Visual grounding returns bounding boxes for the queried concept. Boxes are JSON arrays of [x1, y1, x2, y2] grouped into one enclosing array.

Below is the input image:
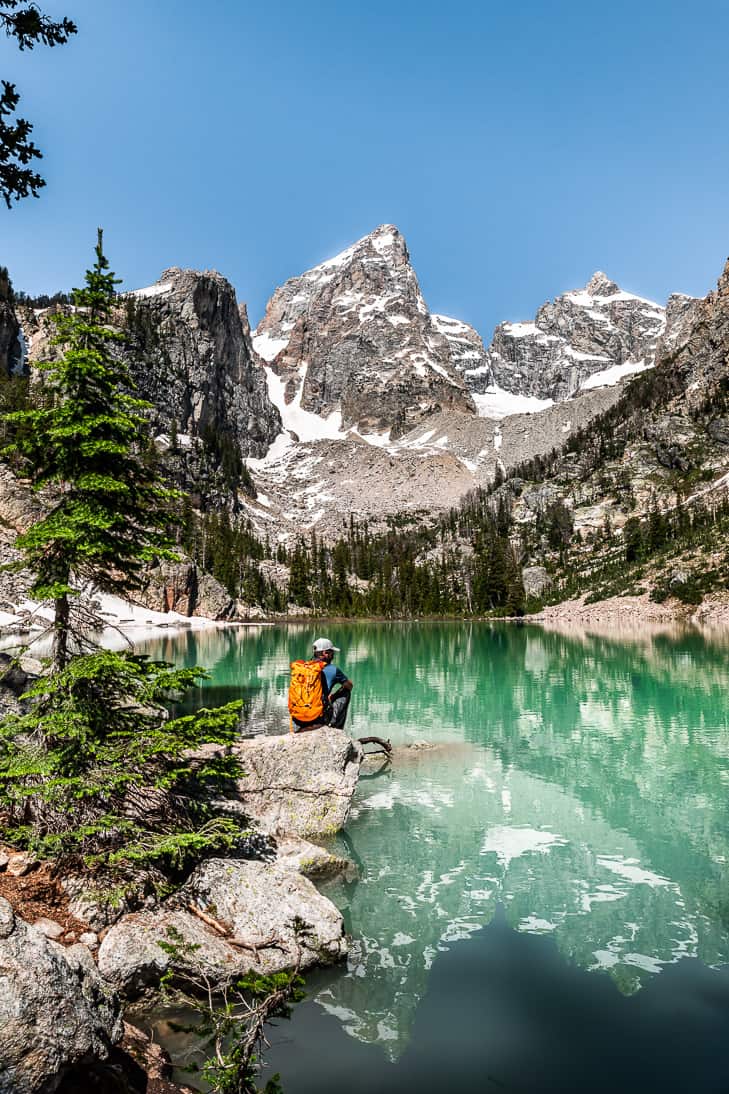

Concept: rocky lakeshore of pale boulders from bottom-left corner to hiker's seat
[[0, 722, 362, 1094]]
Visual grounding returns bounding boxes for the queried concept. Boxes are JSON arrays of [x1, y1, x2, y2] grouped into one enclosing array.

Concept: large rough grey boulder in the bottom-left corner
[[0, 898, 123, 1094]]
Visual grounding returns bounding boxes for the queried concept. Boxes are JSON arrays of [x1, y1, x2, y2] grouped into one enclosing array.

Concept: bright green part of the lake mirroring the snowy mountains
[[134, 624, 729, 1080]]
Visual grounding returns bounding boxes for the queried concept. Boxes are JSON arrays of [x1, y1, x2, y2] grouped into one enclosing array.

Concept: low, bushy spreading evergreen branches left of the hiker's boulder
[[0, 651, 242, 874]]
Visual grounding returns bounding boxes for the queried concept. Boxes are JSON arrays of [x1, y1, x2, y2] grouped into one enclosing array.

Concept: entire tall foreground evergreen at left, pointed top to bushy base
[[0, 232, 247, 884]]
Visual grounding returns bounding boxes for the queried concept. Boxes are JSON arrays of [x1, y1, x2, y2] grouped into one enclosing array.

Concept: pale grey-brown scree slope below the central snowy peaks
[[240, 385, 621, 540]]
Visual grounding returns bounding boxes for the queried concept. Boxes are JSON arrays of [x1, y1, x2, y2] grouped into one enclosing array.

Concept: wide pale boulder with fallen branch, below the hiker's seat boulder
[[99, 859, 347, 999]]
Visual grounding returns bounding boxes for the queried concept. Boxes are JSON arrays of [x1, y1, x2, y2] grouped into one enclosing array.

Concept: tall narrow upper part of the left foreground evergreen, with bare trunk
[[4, 230, 172, 672]]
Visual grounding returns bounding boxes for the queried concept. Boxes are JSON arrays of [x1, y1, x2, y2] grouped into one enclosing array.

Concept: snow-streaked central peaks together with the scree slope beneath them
[[248, 242, 669, 537]]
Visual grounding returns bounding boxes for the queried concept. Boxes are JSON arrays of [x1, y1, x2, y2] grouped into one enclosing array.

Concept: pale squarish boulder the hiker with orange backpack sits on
[[228, 729, 362, 836]]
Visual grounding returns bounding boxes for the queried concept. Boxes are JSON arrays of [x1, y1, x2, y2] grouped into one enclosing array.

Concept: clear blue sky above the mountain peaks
[[0, 0, 729, 339]]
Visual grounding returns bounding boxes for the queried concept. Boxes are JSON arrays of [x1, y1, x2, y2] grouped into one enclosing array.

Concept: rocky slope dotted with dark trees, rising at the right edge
[[486, 253, 729, 606]]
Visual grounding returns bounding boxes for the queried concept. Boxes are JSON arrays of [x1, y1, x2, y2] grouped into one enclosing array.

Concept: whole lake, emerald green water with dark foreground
[[139, 624, 729, 1094]]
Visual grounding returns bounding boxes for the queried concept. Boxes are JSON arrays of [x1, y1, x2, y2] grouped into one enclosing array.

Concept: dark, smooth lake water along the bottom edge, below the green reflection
[[265, 913, 729, 1094]]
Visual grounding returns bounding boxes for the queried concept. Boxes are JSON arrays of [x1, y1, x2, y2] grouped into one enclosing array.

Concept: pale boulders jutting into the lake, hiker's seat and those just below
[[99, 730, 362, 998]]
